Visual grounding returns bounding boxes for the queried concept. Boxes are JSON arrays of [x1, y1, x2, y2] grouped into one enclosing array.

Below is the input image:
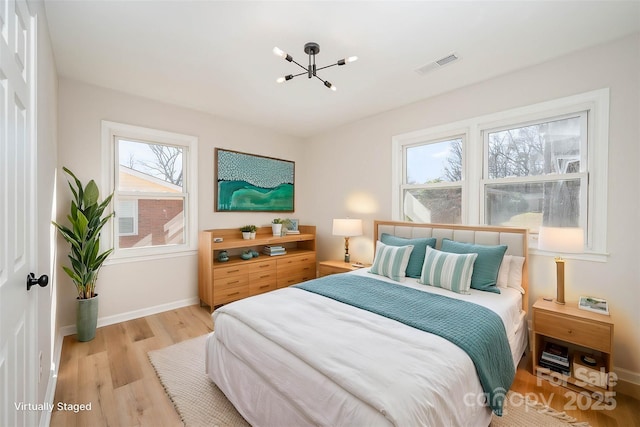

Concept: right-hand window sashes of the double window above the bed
[[482, 111, 588, 234]]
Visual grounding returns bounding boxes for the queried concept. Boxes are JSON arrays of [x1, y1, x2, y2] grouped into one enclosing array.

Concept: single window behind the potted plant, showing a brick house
[[103, 122, 197, 259]]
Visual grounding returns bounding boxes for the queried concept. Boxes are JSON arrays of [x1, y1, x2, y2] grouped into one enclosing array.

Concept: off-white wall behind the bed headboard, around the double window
[[299, 36, 640, 383]]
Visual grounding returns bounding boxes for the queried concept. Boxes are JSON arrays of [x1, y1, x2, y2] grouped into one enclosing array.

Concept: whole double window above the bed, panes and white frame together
[[392, 89, 609, 261]]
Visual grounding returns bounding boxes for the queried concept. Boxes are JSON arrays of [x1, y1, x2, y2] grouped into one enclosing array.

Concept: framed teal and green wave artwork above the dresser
[[214, 148, 295, 212]]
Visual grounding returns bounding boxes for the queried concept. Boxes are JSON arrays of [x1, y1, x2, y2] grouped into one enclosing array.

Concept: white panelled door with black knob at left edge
[[0, 0, 41, 426]]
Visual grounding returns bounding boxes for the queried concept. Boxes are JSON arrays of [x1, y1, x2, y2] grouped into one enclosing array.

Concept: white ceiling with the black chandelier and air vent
[[45, 0, 640, 138]]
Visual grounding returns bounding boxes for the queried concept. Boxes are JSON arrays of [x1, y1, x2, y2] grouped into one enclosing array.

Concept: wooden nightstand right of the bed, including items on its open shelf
[[531, 298, 615, 402]]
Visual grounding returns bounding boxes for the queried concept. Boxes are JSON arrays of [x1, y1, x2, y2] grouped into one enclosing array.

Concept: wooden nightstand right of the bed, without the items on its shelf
[[531, 298, 615, 400]]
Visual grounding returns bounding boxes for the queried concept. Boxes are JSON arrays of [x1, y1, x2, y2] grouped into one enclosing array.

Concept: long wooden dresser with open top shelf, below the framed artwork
[[198, 225, 316, 311]]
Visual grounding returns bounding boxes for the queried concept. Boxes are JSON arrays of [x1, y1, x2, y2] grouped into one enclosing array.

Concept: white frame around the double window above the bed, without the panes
[[391, 88, 609, 262]]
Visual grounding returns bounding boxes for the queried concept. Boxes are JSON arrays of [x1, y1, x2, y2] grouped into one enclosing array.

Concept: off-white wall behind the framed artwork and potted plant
[[57, 78, 306, 326]]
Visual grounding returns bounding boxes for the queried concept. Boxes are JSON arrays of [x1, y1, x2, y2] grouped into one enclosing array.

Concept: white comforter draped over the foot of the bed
[[207, 273, 518, 426]]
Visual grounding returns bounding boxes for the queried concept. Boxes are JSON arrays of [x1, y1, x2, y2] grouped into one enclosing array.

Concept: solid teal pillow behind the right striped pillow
[[441, 239, 507, 294]]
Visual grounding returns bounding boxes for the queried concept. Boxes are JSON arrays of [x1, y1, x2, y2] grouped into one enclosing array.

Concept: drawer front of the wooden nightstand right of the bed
[[533, 310, 612, 353]]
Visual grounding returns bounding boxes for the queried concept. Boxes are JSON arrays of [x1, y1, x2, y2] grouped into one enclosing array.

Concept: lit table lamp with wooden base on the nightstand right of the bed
[[538, 227, 584, 304]]
